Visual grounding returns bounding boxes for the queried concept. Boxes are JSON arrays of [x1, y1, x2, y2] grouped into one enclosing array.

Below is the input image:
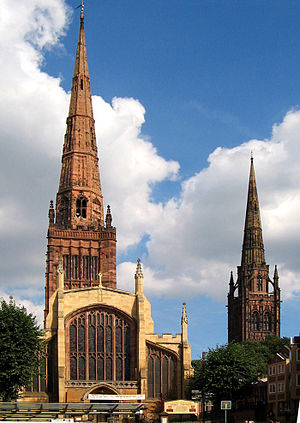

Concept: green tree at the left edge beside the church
[[0, 299, 42, 401]]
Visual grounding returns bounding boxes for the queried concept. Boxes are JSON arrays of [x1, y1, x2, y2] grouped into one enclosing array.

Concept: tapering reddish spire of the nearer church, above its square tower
[[56, 7, 104, 229]]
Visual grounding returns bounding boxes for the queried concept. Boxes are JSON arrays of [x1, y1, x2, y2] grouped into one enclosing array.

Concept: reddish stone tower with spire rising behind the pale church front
[[45, 10, 116, 317]]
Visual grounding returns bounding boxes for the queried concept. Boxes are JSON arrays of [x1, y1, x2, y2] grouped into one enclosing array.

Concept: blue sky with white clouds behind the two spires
[[0, 0, 300, 358]]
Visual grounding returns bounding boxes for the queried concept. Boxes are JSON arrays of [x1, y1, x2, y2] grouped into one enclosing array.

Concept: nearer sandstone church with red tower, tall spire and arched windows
[[44, 7, 192, 414]]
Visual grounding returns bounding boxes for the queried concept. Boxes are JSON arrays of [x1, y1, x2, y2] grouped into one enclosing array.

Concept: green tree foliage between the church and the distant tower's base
[[190, 336, 289, 405]]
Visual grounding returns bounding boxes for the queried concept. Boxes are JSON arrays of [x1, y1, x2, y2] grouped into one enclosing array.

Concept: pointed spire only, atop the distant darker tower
[[241, 156, 265, 266]]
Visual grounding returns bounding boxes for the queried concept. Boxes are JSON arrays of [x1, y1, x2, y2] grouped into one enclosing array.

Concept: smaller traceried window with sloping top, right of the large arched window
[[147, 345, 177, 399]]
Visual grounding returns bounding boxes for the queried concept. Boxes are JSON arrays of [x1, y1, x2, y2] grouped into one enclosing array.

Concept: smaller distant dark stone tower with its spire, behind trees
[[228, 157, 280, 342]]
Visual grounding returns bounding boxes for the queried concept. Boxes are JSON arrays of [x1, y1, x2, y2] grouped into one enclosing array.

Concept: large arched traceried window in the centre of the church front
[[67, 308, 135, 381]]
